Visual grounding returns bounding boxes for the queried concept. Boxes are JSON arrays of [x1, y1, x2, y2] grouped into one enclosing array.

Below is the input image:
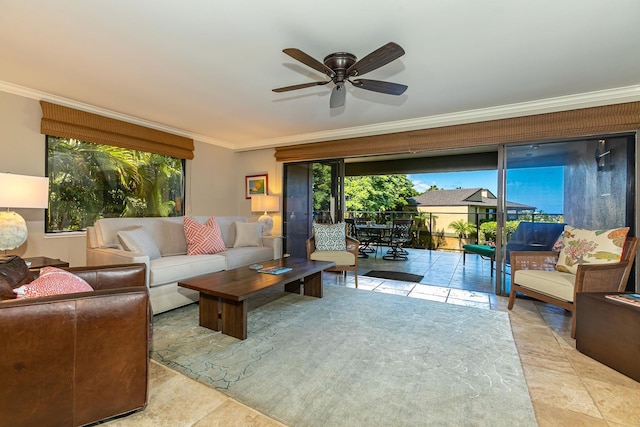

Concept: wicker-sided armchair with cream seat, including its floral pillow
[[507, 225, 638, 338]]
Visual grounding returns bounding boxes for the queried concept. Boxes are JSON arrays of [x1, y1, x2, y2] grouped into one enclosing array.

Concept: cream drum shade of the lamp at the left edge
[[0, 173, 49, 209]]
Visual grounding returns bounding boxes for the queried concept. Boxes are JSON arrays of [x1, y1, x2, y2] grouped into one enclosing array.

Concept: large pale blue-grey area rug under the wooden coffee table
[[152, 285, 536, 427]]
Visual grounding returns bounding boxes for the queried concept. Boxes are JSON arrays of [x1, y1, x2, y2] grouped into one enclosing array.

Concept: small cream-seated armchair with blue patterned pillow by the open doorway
[[306, 223, 360, 288]]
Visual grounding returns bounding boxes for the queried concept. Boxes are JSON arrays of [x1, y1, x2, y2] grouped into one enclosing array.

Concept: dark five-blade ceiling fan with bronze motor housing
[[273, 42, 407, 108]]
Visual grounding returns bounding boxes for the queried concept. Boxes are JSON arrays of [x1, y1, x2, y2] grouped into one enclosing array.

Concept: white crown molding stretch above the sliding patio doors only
[[236, 85, 640, 151]]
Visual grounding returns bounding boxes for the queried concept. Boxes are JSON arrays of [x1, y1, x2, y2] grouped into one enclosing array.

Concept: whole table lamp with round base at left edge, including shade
[[0, 173, 49, 260]]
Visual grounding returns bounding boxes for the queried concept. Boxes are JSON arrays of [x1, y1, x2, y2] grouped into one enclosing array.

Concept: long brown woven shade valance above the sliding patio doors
[[275, 102, 640, 162]]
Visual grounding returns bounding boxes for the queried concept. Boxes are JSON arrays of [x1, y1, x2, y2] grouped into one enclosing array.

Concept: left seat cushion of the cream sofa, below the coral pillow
[[149, 254, 226, 287]]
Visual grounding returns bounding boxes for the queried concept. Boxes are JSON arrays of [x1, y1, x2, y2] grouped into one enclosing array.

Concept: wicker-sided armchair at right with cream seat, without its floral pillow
[[507, 232, 638, 338]]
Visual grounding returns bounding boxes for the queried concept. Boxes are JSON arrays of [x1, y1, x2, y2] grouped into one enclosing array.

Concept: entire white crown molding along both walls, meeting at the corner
[[0, 80, 640, 152]]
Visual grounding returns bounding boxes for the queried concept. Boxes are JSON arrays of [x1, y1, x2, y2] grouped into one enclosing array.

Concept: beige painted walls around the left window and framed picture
[[0, 91, 282, 266]]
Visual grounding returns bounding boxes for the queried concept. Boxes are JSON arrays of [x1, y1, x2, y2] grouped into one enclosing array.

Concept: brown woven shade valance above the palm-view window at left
[[40, 101, 193, 159]]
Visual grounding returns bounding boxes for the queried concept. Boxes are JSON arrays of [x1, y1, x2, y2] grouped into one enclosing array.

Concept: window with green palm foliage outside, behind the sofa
[[45, 135, 185, 233]]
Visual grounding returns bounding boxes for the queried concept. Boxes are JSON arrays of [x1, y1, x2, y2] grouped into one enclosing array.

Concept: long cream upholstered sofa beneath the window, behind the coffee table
[[87, 216, 282, 314]]
